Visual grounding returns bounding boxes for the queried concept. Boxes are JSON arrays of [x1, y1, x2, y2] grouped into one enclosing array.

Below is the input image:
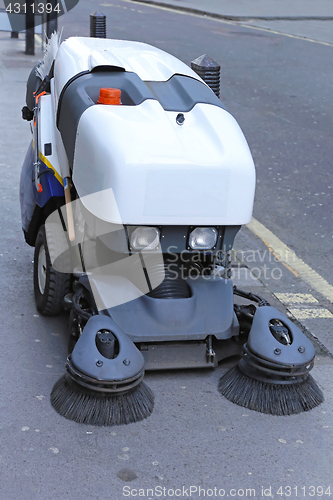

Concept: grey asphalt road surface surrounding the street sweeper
[[0, 0, 333, 500]]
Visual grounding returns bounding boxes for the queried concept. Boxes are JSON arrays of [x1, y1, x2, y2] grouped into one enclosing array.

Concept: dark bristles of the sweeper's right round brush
[[218, 365, 324, 415]]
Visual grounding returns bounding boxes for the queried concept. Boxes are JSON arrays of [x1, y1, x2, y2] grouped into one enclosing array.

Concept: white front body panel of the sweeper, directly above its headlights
[[73, 100, 255, 225]]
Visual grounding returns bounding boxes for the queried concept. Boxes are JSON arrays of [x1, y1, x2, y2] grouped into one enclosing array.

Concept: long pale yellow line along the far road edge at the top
[[124, 0, 333, 47]]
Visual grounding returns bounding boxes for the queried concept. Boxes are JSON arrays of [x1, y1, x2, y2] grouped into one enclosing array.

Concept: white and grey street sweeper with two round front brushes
[[20, 34, 323, 425]]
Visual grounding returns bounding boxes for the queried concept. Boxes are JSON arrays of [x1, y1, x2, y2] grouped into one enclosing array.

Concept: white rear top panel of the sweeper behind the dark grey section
[[54, 37, 202, 107]]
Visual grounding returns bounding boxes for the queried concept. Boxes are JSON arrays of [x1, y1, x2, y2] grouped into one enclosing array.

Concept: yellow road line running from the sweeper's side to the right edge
[[247, 219, 333, 302]]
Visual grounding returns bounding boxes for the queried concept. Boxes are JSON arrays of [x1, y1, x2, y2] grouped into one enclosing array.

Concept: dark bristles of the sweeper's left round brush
[[51, 374, 154, 426]]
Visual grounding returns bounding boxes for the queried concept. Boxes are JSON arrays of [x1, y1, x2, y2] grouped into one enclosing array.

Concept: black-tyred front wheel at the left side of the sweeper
[[34, 225, 70, 316]]
